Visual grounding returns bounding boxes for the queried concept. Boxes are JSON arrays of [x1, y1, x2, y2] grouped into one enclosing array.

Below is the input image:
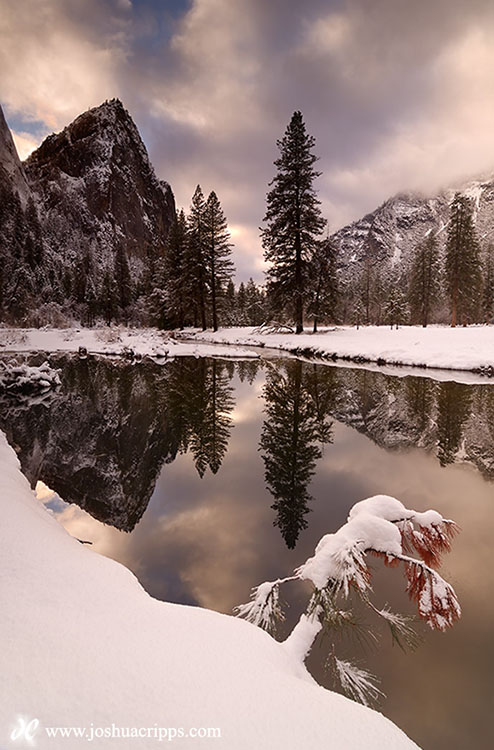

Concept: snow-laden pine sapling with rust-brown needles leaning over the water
[[235, 495, 461, 704]]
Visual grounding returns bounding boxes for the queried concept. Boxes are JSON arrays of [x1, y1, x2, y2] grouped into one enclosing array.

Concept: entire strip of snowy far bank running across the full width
[[0, 326, 494, 384]]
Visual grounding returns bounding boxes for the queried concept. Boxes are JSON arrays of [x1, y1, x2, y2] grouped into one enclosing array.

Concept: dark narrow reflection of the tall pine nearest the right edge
[[437, 382, 472, 466]]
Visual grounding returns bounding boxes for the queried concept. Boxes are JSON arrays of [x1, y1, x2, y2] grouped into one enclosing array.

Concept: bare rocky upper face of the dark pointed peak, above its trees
[[25, 99, 175, 258]]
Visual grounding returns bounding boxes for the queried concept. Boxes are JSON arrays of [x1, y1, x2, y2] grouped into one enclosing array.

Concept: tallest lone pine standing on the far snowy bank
[[262, 112, 325, 333]]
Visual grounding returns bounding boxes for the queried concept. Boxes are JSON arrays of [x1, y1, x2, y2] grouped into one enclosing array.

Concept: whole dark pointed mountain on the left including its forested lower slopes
[[0, 99, 175, 325]]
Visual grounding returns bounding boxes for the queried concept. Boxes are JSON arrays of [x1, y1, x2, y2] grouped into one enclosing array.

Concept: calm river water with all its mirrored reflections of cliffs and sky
[[0, 358, 494, 750]]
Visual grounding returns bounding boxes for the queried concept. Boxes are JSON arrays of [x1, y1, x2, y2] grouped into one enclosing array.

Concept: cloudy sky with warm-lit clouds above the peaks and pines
[[0, 0, 494, 278]]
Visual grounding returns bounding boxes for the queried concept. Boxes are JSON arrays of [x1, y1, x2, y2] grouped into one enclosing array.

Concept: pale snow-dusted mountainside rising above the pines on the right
[[332, 178, 494, 278]]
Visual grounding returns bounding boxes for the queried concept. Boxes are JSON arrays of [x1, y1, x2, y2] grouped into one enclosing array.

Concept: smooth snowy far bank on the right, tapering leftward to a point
[[194, 326, 494, 382]]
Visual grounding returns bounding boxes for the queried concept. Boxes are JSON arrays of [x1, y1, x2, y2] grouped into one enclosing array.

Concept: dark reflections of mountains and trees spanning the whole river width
[[0, 357, 494, 549]]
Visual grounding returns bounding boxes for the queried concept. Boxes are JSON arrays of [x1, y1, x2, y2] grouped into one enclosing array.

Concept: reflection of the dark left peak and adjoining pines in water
[[0, 359, 237, 531]]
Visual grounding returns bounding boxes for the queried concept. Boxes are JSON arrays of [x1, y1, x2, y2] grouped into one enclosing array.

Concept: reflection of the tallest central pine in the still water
[[260, 361, 328, 549]]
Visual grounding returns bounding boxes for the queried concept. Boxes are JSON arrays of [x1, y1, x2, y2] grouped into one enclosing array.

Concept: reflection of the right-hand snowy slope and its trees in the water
[[326, 370, 494, 480]]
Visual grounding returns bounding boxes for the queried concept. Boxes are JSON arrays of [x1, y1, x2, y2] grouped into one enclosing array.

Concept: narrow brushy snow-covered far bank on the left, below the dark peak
[[0, 327, 259, 359]]
